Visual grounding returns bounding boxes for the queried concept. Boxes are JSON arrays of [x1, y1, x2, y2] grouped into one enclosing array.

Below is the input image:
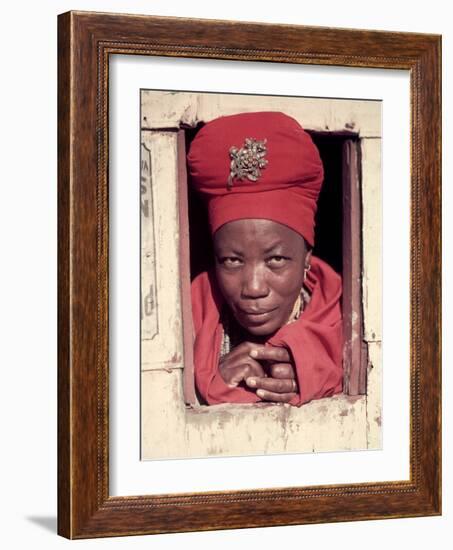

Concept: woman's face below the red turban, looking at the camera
[[214, 219, 309, 336]]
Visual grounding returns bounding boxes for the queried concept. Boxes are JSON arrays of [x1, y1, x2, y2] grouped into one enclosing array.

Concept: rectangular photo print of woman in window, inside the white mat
[[140, 89, 382, 460]]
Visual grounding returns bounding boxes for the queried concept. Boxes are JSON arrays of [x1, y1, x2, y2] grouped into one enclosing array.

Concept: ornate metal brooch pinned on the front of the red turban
[[227, 138, 268, 189]]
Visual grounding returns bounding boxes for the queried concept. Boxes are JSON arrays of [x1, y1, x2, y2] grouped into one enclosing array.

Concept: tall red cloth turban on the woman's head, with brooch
[[187, 112, 324, 246]]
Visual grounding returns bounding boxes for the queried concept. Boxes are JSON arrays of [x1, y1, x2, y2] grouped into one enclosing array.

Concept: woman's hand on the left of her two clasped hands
[[219, 342, 266, 389]]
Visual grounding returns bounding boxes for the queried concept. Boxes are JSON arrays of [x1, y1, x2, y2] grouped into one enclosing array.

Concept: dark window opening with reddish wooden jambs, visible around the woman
[[178, 128, 367, 405]]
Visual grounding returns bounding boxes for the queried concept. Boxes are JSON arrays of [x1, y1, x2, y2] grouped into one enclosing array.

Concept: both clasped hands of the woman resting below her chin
[[219, 342, 298, 403]]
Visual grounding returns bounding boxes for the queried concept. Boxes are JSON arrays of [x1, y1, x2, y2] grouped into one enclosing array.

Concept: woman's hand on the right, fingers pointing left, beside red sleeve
[[246, 346, 298, 403]]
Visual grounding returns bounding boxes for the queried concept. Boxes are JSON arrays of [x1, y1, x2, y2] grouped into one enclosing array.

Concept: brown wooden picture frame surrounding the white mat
[[58, 12, 441, 538]]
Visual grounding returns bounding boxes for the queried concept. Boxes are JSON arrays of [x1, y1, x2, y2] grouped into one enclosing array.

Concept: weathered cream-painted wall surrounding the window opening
[[141, 91, 382, 459]]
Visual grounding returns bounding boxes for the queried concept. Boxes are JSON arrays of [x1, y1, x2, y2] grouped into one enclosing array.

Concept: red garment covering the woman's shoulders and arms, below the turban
[[192, 257, 343, 406]]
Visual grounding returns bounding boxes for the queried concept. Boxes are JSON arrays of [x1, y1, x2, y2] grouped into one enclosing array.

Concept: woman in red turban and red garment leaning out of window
[[188, 112, 343, 405]]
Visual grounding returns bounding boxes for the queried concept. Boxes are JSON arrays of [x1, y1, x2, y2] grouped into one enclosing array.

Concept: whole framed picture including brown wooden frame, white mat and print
[[58, 12, 441, 538]]
